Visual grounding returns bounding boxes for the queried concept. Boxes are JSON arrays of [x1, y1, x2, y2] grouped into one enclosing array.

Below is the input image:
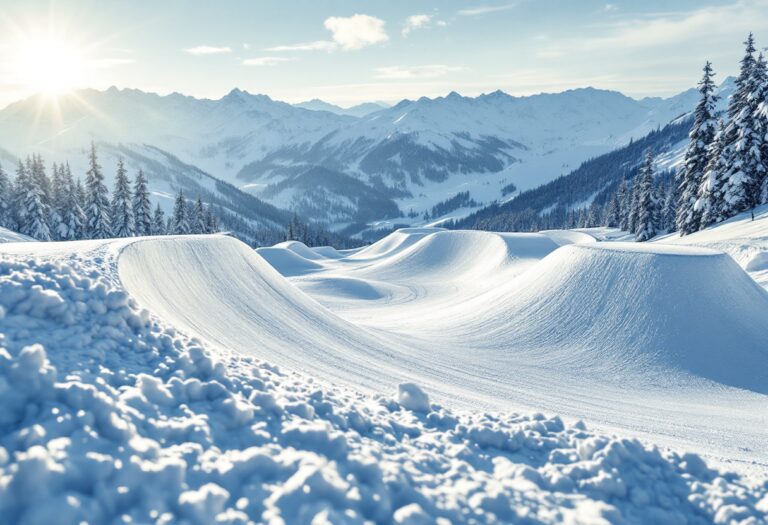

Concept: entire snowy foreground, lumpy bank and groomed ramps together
[[0, 224, 768, 525]]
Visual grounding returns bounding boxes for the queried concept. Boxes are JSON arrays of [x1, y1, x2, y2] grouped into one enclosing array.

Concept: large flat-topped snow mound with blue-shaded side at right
[[474, 243, 768, 393]]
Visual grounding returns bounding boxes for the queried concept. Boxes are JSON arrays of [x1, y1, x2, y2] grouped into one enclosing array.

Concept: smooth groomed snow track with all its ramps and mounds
[[118, 228, 768, 471]]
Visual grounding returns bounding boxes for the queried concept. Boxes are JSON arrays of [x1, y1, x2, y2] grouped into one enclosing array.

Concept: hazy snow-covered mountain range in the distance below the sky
[[0, 80, 732, 231]]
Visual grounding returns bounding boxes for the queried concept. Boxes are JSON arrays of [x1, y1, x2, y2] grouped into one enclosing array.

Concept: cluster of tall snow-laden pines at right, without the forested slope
[[600, 33, 768, 241]]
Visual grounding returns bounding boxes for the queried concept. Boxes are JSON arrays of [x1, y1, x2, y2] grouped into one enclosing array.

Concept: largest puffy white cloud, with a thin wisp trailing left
[[265, 14, 389, 53]]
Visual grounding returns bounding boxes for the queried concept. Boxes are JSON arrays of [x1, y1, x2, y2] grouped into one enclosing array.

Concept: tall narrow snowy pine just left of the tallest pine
[[676, 62, 718, 235]]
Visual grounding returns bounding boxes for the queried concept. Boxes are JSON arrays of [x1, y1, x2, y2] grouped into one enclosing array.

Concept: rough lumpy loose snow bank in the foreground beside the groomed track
[[0, 252, 768, 525]]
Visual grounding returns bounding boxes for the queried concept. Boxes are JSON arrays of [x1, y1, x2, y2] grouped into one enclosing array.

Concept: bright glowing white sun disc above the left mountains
[[13, 35, 85, 97]]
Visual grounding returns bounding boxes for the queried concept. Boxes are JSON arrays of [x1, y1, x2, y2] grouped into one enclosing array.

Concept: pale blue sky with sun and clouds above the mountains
[[0, 0, 768, 107]]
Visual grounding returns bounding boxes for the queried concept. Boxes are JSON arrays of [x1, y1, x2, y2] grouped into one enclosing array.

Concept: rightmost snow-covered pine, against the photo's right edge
[[723, 54, 766, 216]]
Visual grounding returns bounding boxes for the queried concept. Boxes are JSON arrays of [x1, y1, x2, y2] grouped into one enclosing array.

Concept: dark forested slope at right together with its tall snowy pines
[[446, 33, 768, 241]]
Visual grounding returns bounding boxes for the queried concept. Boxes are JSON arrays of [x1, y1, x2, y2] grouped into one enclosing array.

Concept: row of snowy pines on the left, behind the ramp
[[0, 144, 219, 241]]
